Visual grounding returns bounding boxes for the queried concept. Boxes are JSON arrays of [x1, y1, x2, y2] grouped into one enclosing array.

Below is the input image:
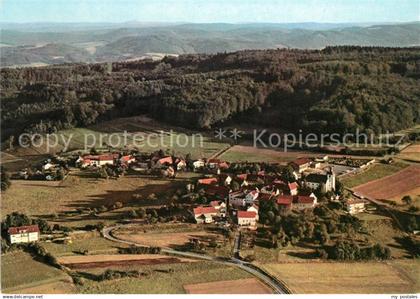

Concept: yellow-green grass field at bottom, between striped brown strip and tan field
[[78, 262, 251, 294]]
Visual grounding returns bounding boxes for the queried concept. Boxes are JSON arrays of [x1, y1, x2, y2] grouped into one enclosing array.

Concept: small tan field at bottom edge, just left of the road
[[184, 278, 273, 294]]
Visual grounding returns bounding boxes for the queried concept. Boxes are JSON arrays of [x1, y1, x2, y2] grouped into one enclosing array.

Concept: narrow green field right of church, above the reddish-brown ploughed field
[[341, 162, 409, 188]]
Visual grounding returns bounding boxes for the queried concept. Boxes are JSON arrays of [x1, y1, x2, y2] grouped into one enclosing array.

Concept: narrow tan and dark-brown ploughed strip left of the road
[[58, 254, 194, 269]]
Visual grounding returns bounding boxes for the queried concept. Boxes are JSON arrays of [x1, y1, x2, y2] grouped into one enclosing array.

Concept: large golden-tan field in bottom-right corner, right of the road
[[263, 260, 420, 294]]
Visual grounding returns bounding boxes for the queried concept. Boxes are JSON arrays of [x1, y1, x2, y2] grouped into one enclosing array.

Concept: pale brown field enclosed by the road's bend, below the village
[[114, 230, 220, 247]]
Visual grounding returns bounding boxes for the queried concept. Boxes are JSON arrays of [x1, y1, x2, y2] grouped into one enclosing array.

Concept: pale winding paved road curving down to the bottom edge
[[102, 224, 291, 294]]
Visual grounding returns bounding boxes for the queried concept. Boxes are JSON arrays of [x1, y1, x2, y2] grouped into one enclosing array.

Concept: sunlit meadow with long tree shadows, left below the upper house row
[[1, 170, 180, 221]]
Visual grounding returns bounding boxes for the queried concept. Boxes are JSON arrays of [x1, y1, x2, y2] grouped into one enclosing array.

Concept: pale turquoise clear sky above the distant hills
[[0, 0, 420, 23]]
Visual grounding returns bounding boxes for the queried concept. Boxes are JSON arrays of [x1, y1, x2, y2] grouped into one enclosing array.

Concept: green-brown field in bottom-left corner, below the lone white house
[[1, 251, 68, 291]]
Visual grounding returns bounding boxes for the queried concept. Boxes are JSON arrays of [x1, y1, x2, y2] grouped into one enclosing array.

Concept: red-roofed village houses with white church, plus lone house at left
[[4, 149, 372, 248]]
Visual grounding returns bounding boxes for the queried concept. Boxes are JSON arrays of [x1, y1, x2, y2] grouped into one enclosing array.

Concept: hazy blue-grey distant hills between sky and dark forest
[[1, 22, 420, 66]]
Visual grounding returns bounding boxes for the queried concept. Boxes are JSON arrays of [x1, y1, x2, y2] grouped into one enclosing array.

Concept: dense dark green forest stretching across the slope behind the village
[[0, 46, 420, 141]]
